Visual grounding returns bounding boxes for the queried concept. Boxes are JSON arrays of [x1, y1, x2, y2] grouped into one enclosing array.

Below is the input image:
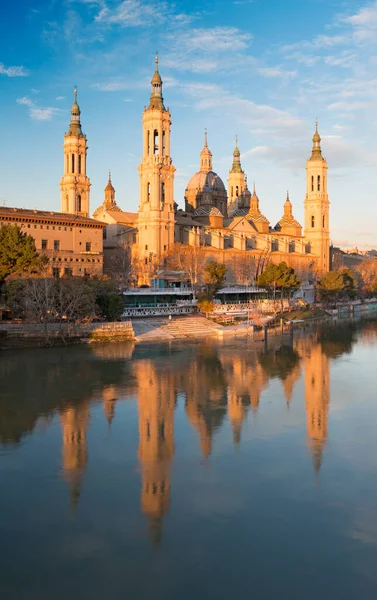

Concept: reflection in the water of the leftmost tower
[[60, 402, 89, 505]]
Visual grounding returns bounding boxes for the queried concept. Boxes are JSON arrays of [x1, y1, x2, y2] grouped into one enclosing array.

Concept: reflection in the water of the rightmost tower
[[304, 344, 330, 473]]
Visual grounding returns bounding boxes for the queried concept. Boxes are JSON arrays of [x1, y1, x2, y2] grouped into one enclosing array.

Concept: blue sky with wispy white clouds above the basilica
[[0, 0, 377, 248]]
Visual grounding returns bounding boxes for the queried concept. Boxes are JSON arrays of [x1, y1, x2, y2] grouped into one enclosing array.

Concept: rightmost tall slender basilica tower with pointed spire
[[304, 122, 330, 275]]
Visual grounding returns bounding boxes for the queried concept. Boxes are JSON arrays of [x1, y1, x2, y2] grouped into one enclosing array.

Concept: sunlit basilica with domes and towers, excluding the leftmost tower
[[89, 57, 330, 283]]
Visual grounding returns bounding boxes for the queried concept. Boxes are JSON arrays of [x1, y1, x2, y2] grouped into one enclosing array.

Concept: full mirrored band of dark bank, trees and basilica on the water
[[0, 323, 377, 545]]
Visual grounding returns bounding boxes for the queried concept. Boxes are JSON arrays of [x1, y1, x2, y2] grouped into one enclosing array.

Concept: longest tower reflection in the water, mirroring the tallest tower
[[135, 360, 176, 544]]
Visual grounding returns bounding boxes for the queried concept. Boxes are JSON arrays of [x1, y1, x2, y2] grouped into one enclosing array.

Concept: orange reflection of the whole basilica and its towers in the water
[[61, 337, 330, 544]]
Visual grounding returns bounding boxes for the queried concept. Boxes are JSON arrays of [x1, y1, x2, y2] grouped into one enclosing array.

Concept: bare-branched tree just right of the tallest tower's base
[[166, 244, 206, 299]]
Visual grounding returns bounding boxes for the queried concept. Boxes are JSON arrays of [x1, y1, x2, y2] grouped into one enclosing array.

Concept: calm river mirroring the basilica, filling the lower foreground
[[0, 322, 377, 600]]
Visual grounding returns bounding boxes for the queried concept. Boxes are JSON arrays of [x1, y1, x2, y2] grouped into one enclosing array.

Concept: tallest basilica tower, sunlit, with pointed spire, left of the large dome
[[138, 56, 175, 266]]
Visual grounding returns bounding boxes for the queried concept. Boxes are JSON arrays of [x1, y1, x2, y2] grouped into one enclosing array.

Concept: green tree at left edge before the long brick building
[[0, 225, 47, 283]]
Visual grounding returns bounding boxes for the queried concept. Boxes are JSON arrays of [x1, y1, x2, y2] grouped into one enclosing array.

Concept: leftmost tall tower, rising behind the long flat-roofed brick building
[[60, 89, 90, 217]]
